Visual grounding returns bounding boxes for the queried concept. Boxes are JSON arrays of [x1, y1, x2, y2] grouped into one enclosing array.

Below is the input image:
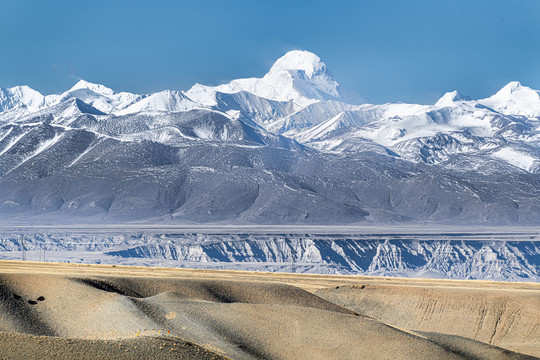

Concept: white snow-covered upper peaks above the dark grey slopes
[[0, 50, 540, 172]]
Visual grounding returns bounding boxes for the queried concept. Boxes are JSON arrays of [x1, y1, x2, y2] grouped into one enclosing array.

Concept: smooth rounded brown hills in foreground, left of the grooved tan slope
[[0, 275, 527, 359]]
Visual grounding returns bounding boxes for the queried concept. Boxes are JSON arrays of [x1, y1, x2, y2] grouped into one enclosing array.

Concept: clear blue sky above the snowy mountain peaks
[[0, 0, 540, 103]]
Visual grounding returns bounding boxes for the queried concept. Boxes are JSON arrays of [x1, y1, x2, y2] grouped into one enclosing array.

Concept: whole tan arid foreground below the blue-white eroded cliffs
[[0, 261, 540, 359]]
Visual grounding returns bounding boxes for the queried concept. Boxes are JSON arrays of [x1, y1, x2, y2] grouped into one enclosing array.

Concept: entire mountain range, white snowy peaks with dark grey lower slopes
[[0, 51, 540, 224]]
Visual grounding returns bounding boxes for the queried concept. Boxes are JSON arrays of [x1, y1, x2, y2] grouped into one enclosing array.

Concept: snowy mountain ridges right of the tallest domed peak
[[278, 83, 540, 172]]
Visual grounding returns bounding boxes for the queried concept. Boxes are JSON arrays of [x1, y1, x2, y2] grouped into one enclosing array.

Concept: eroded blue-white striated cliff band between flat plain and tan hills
[[0, 233, 540, 281]]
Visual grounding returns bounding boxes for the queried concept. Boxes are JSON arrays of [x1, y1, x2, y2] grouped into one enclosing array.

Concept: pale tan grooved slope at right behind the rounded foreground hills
[[316, 282, 540, 355]]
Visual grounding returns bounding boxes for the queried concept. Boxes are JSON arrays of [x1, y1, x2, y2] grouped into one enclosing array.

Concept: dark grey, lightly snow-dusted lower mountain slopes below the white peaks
[[0, 110, 540, 225]]
